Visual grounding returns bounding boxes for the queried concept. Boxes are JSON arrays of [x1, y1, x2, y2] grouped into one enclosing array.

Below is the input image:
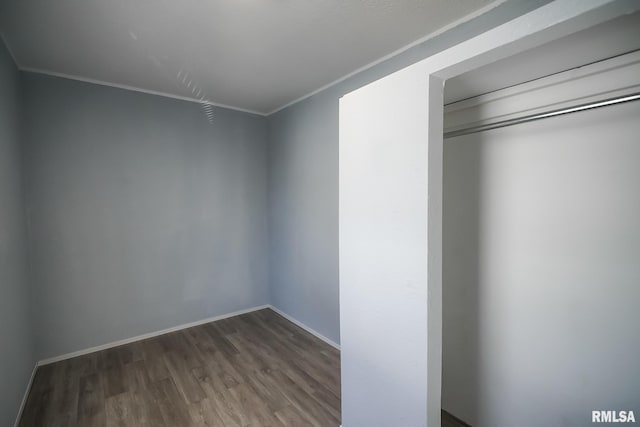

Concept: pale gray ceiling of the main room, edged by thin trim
[[0, 0, 501, 113]]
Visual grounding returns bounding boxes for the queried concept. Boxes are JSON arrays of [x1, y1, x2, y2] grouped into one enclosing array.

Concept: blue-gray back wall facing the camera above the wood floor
[[24, 73, 269, 359]]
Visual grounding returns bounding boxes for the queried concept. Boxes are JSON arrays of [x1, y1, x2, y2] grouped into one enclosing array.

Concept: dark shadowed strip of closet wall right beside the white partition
[[442, 132, 482, 424]]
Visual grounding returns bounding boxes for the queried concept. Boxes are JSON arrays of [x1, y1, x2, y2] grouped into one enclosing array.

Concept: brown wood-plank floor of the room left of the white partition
[[20, 309, 340, 427]]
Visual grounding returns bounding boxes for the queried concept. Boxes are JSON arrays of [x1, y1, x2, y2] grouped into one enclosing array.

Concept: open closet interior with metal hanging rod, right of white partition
[[441, 13, 640, 427]]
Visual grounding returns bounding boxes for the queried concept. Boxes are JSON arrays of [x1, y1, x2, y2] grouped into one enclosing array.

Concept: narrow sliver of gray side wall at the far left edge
[[0, 42, 34, 426]]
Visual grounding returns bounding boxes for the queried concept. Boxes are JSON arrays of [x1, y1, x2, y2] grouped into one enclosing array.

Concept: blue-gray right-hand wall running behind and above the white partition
[[268, 0, 549, 342]]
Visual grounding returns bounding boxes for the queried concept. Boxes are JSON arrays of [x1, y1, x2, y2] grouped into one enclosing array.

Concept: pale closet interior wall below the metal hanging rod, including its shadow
[[442, 101, 640, 427]]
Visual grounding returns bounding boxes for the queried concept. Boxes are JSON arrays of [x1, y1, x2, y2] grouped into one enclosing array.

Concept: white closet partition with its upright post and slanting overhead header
[[339, 0, 640, 427]]
